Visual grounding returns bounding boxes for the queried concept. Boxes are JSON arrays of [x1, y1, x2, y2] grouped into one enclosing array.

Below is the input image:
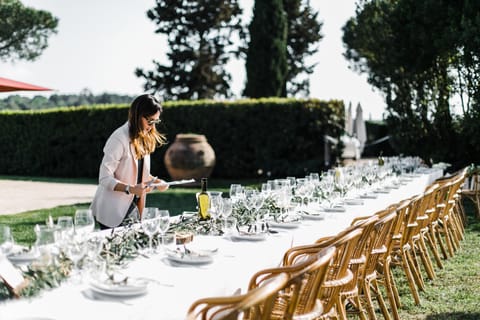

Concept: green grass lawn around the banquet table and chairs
[[0, 180, 480, 320]]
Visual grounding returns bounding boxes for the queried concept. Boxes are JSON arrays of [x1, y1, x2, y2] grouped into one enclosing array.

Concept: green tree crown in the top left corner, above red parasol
[[0, 0, 58, 61]]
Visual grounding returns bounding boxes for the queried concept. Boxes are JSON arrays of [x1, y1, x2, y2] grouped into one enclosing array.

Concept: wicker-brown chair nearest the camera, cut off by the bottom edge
[[187, 273, 291, 320]]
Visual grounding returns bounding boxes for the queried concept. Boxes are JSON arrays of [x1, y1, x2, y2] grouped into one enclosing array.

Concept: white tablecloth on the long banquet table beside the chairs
[[0, 169, 443, 320]]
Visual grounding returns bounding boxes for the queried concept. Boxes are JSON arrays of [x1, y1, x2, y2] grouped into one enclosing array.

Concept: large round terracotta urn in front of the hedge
[[164, 133, 215, 181]]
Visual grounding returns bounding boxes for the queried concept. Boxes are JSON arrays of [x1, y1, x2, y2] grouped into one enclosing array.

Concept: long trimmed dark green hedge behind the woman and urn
[[0, 98, 344, 178]]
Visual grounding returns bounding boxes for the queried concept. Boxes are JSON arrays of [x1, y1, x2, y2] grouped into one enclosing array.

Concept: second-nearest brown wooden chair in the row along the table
[[248, 247, 336, 319]]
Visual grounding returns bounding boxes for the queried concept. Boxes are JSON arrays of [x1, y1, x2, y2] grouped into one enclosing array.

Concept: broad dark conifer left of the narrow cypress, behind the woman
[[135, 0, 243, 100]]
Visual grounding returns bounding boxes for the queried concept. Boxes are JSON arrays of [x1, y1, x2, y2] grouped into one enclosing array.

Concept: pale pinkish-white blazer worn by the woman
[[90, 122, 150, 228]]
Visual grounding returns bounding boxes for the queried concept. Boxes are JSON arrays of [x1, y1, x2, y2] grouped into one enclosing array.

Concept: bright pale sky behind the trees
[[0, 0, 385, 119]]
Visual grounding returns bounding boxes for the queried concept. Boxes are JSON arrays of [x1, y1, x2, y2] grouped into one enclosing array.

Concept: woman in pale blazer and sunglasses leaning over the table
[[91, 94, 168, 229]]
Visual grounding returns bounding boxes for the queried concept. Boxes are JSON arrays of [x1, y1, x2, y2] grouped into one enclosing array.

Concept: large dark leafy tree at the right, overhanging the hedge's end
[[343, 0, 480, 169]]
